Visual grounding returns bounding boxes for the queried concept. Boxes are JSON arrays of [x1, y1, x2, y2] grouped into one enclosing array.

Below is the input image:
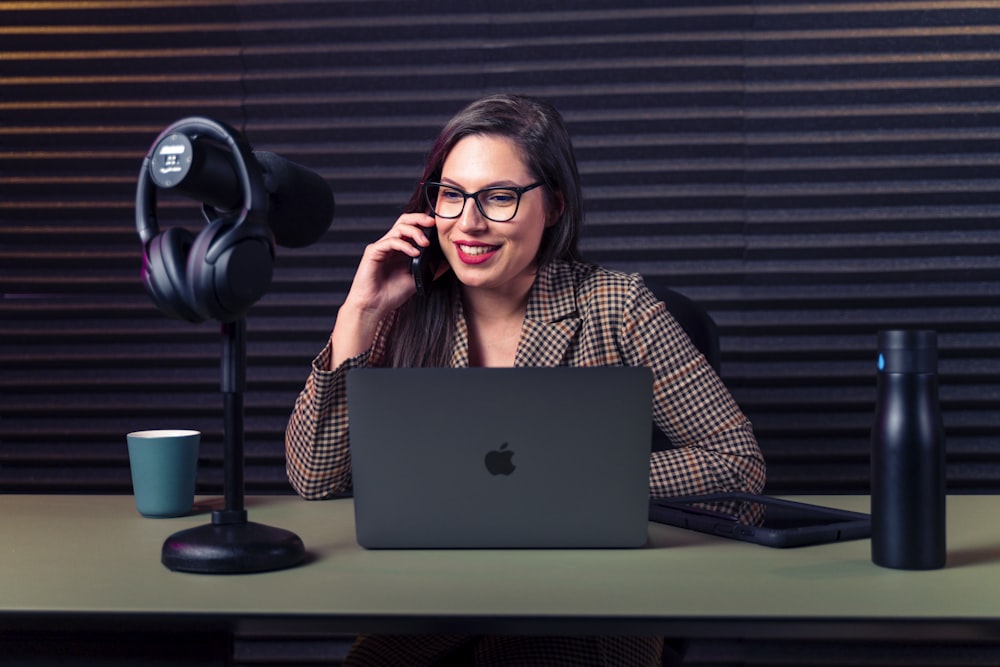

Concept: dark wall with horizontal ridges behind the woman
[[0, 0, 1000, 500]]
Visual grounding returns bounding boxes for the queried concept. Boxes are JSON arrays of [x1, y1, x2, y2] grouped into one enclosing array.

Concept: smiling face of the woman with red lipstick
[[437, 135, 554, 295]]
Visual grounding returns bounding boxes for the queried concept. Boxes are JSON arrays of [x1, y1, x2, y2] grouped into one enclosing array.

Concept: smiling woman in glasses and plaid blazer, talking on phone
[[286, 95, 764, 664]]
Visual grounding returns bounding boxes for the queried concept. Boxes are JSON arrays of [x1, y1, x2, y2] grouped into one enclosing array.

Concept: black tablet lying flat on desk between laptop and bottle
[[649, 493, 872, 547]]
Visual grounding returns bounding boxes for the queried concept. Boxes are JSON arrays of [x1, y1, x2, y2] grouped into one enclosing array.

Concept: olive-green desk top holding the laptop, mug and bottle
[[0, 495, 1000, 640]]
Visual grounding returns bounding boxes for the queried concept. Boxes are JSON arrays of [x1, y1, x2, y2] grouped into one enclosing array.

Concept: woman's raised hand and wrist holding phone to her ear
[[330, 213, 434, 368]]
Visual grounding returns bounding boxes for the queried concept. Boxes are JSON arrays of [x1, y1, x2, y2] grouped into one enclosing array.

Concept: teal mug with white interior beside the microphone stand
[[127, 430, 201, 518]]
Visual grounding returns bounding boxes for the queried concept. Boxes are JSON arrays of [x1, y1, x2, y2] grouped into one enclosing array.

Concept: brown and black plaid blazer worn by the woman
[[285, 262, 765, 500]]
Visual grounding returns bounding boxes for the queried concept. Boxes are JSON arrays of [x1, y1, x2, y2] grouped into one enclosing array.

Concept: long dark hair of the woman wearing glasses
[[385, 94, 583, 366]]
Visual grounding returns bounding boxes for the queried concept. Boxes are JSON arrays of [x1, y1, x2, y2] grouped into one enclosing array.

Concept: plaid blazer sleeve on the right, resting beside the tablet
[[619, 276, 766, 498]]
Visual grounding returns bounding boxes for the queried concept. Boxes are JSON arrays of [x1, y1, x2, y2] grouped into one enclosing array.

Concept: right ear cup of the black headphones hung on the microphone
[[186, 221, 274, 322]]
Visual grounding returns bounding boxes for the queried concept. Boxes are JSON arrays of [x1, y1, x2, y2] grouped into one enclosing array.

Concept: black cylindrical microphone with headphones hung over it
[[149, 132, 334, 248]]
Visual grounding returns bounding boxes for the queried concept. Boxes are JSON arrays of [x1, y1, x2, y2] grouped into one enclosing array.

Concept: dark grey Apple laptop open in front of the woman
[[347, 367, 653, 549]]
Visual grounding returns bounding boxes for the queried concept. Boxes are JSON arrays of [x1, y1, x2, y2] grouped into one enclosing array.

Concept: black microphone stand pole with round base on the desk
[[161, 318, 305, 574]]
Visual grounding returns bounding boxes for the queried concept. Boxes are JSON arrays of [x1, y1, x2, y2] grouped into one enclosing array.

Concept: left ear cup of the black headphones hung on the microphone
[[142, 227, 204, 323]]
